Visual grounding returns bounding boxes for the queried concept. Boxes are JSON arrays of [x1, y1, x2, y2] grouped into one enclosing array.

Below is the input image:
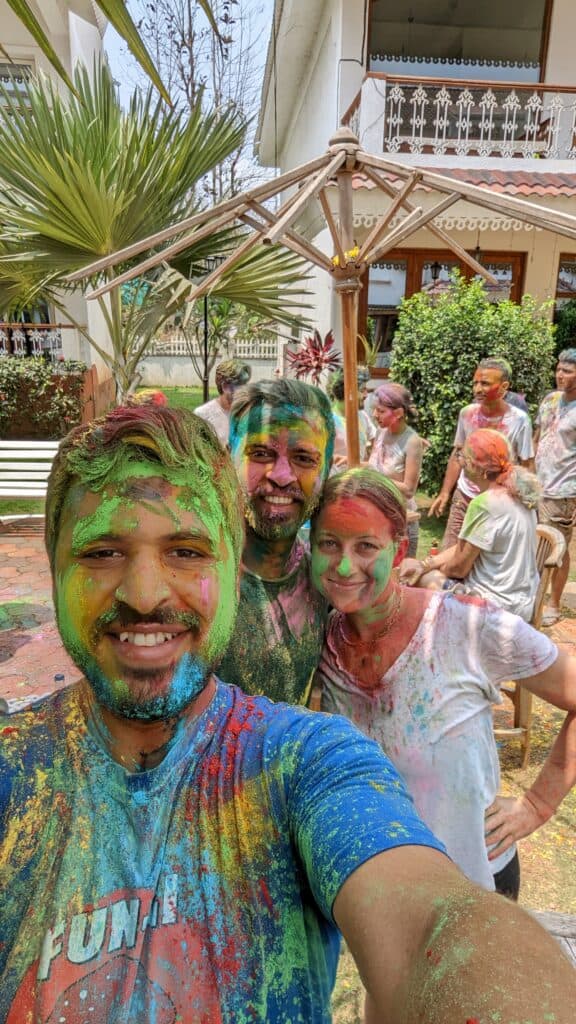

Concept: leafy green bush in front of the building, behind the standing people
[[392, 275, 554, 494]]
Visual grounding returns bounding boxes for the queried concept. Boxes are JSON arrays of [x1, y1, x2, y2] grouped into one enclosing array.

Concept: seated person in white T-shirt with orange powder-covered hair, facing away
[[401, 430, 540, 622]]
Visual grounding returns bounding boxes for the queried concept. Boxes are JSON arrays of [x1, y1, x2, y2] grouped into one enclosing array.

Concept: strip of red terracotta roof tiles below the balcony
[[353, 167, 576, 197]]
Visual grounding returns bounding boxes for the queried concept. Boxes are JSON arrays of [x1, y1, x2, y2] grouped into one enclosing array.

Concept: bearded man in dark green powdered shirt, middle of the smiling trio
[[217, 378, 335, 703]]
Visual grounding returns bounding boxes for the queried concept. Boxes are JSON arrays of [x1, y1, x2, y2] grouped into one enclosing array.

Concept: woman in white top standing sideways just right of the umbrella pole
[[369, 381, 424, 557]]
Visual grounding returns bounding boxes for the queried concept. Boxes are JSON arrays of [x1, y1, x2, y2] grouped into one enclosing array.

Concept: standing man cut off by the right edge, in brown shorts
[[535, 348, 576, 626]]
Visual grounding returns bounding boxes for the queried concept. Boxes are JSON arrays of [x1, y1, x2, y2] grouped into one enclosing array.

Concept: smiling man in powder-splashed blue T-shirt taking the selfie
[[0, 407, 576, 1024]]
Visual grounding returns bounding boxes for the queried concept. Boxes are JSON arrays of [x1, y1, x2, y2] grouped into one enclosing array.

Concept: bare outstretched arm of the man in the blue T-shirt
[[334, 846, 576, 1024]]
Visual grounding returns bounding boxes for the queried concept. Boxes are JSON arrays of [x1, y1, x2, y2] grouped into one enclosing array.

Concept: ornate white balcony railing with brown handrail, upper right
[[342, 73, 576, 160]]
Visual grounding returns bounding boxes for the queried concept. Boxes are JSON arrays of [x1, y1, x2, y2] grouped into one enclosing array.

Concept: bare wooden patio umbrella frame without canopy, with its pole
[[68, 128, 576, 466]]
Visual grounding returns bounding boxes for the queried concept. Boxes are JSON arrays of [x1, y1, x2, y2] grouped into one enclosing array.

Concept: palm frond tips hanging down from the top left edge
[[0, 0, 218, 102]]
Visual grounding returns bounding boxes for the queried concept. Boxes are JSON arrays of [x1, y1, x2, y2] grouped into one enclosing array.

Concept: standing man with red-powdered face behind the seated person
[[428, 358, 534, 549]]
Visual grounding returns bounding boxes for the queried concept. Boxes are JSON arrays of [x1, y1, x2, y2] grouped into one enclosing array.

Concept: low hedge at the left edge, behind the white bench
[[0, 356, 86, 439]]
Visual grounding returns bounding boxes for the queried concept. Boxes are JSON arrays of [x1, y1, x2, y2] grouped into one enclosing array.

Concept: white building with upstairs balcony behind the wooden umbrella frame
[[256, 0, 576, 368]]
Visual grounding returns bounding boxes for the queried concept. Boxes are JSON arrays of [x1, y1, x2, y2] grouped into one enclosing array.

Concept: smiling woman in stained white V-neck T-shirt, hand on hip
[[312, 468, 576, 898]]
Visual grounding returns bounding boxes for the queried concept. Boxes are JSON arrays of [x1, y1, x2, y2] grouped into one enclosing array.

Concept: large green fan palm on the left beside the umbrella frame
[[0, 66, 302, 399]]
